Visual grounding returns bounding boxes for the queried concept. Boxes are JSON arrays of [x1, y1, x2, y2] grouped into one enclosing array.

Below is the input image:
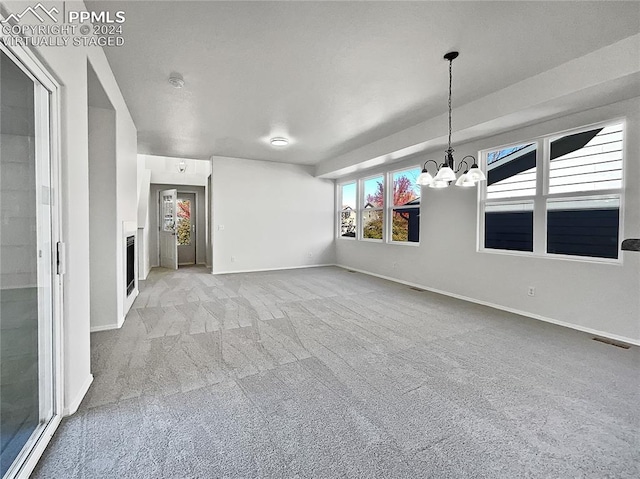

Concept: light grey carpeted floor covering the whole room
[[34, 267, 640, 479]]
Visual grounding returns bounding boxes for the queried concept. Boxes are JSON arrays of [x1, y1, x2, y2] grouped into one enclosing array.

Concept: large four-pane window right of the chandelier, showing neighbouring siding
[[482, 122, 624, 259]]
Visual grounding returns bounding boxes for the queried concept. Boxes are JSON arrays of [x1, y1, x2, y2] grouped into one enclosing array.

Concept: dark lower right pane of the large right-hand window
[[547, 198, 620, 258]]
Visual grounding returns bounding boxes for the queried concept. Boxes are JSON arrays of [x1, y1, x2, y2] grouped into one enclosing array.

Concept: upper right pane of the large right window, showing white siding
[[549, 124, 622, 194]]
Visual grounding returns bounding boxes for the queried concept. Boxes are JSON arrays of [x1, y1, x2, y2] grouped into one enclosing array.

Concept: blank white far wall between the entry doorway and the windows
[[211, 157, 335, 273]]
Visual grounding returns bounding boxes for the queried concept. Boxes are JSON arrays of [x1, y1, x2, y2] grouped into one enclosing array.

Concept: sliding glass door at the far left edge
[[0, 47, 59, 477]]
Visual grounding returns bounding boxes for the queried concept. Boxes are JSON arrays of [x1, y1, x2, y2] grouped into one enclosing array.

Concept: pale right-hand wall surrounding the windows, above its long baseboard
[[336, 98, 640, 343]]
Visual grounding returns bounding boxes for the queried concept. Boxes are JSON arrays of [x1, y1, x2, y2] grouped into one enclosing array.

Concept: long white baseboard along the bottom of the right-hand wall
[[335, 264, 640, 346]]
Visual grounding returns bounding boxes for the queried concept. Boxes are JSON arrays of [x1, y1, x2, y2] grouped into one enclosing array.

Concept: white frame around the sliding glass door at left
[[0, 36, 64, 479]]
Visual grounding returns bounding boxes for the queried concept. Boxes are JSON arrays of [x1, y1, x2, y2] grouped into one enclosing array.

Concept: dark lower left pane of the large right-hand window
[[484, 202, 533, 251]]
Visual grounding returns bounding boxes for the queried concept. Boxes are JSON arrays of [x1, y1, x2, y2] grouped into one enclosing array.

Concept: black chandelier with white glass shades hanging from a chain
[[417, 52, 487, 188]]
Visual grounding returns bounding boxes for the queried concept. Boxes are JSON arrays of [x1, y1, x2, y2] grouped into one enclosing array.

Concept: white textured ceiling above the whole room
[[85, 1, 640, 164]]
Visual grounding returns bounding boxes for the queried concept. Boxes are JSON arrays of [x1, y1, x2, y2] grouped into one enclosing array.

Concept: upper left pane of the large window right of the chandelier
[[487, 143, 537, 199]]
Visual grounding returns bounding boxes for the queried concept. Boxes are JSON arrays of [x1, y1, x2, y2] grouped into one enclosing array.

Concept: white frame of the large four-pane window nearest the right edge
[[476, 117, 628, 265]]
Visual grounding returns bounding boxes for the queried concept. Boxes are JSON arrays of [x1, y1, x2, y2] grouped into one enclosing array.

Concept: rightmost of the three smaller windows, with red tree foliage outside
[[389, 167, 421, 243]]
